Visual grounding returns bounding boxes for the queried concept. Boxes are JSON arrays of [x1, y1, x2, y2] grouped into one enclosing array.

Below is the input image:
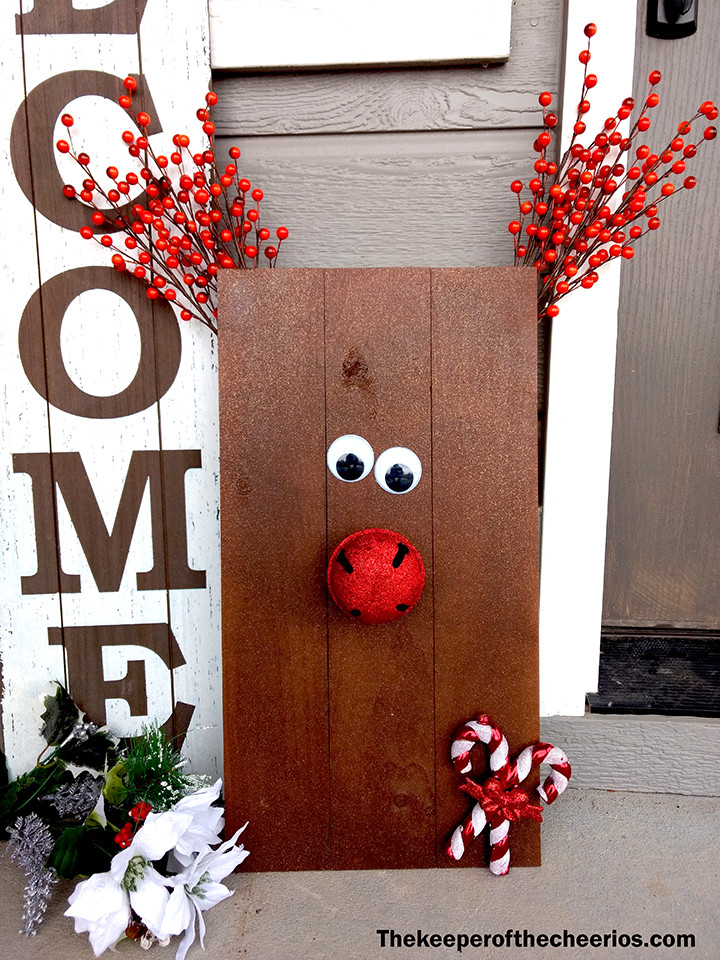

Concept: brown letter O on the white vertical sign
[[18, 267, 182, 420]]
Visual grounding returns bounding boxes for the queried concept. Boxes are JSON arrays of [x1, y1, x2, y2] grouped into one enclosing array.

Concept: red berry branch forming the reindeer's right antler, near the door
[[508, 23, 718, 320]]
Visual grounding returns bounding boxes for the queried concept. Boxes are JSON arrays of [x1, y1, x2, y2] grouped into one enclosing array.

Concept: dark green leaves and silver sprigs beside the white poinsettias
[[0, 683, 205, 933]]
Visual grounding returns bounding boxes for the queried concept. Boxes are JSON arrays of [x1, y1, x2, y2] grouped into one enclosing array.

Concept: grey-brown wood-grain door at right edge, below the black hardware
[[604, 4, 720, 628]]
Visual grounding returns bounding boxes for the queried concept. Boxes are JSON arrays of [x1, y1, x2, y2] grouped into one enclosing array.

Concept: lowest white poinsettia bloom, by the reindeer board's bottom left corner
[[154, 824, 249, 960]]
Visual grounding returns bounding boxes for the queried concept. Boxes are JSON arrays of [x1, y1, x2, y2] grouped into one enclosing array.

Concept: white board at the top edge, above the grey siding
[[210, 0, 511, 70]]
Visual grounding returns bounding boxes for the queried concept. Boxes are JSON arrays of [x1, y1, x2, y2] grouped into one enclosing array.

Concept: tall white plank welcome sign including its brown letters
[[0, 0, 221, 774]]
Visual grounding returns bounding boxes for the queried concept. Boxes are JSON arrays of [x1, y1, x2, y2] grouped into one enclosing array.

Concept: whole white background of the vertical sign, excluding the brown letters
[[0, 0, 217, 774]]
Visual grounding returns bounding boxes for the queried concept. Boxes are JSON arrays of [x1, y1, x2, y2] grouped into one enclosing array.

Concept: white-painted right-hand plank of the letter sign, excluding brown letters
[[141, 0, 222, 775]]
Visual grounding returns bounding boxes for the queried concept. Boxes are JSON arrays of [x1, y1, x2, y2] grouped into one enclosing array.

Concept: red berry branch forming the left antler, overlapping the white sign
[[56, 77, 288, 333]]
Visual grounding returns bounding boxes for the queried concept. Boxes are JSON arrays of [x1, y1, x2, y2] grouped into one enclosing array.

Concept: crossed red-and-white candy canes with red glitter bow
[[446, 714, 570, 876]]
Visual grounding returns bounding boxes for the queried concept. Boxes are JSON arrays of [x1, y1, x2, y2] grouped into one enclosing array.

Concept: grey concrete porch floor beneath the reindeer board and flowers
[[0, 789, 720, 960]]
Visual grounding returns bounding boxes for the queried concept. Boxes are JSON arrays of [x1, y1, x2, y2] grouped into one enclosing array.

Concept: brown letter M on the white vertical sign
[[13, 450, 205, 594]]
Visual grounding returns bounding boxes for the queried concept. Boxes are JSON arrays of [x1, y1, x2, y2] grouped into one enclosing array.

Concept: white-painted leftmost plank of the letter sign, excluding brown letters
[[0, 4, 64, 770]]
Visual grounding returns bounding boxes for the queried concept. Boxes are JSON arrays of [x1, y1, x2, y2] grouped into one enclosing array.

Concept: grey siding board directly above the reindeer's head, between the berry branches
[[216, 130, 532, 267]]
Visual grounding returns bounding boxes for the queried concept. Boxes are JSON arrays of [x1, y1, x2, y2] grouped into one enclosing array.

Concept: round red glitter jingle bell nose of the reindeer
[[327, 530, 425, 623]]
